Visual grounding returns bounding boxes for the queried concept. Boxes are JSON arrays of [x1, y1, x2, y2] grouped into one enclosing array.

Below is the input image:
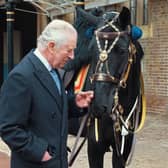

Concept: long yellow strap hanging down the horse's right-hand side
[[135, 72, 146, 133]]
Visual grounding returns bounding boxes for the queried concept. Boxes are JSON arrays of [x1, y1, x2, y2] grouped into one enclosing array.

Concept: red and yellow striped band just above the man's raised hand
[[74, 65, 90, 93]]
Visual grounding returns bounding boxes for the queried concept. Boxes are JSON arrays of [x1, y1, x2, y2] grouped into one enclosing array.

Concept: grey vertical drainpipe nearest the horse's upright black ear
[[130, 0, 137, 25]]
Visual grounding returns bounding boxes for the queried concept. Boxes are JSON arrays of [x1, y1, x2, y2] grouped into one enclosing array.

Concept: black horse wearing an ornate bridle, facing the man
[[65, 7, 143, 168]]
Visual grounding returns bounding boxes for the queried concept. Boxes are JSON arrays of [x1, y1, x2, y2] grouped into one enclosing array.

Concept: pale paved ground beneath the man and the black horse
[[0, 113, 168, 168]]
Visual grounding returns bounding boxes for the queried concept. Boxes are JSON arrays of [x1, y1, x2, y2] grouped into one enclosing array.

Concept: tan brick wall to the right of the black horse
[[141, 0, 168, 114]]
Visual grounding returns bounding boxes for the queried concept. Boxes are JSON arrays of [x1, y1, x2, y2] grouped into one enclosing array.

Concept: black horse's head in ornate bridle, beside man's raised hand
[[90, 7, 137, 116]]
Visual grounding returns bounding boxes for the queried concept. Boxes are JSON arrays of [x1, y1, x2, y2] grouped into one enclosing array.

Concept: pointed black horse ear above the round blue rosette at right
[[119, 7, 131, 30]]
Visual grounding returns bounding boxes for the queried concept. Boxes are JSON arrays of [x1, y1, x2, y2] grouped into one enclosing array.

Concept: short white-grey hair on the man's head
[[37, 19, 77, 49]]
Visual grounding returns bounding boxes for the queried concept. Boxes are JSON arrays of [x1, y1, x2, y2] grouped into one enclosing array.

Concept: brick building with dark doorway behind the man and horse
[[0, 0, 168, 115]]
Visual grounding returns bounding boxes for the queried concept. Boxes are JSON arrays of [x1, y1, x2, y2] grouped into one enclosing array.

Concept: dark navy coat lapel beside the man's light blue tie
[[29, 53, 62, 110]]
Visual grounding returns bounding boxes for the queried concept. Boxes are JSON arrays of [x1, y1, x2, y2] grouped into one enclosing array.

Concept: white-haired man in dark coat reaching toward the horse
[[0, 20, 93, 168]]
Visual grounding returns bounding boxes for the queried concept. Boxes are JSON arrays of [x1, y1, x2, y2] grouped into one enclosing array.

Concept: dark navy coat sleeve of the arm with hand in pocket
[[0, 73, 48, 161]]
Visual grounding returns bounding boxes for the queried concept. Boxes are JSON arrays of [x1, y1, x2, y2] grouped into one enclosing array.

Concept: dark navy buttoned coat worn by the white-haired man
[[0, 51, 68, 168]]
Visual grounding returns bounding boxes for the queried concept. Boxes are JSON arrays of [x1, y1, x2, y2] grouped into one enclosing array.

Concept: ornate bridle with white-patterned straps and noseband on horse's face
[[90, 20, 136, 88]]
